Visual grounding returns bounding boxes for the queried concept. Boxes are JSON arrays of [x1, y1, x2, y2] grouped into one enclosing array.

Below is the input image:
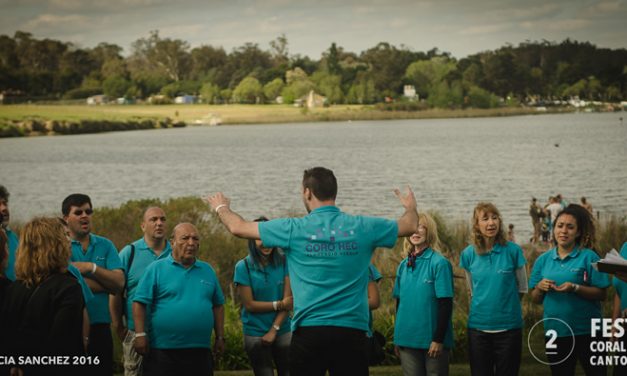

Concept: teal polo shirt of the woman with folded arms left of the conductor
[[233, 258, 291, 337]]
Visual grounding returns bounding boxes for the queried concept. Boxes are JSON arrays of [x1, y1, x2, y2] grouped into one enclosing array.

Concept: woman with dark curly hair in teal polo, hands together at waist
[[529, 205, 610, 375]]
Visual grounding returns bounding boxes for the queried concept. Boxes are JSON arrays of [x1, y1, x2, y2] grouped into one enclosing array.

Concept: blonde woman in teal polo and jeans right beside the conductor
[[393, 213, 453, 376]]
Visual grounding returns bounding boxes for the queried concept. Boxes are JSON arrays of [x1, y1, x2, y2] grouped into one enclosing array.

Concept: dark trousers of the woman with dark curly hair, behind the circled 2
[[546, 335, 607, 376]]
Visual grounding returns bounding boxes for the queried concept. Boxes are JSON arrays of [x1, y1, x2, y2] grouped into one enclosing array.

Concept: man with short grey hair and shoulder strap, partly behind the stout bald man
[[109, 206, 172, 376]]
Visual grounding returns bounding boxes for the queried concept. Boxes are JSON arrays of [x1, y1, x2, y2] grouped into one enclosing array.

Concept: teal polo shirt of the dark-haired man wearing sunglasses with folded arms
[[70, 234, 122, 325]]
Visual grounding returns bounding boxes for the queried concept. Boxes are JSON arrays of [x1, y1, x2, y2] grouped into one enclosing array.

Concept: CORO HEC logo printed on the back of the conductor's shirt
[[305, 227, 359, 257]]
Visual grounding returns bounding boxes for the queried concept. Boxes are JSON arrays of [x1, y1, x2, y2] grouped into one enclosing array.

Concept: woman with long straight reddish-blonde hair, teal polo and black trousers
[[460, 202, 528, 376]]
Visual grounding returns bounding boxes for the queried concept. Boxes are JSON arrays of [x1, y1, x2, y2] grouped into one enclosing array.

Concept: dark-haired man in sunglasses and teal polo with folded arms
[[61, 193, 124, 376]]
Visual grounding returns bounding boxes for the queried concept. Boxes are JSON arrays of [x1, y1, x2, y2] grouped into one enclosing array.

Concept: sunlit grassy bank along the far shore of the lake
[[0, 104, 563, 137]]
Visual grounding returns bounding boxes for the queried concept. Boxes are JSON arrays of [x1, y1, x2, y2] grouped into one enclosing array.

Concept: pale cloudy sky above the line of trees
[[0, 0, 627, 59]]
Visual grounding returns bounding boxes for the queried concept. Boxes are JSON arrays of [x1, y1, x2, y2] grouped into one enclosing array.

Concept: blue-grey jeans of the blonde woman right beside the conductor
[[398, 346, 449, 376]]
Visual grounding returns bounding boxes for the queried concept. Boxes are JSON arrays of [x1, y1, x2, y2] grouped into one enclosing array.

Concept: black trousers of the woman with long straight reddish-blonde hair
[[468, 328, 522, 376]]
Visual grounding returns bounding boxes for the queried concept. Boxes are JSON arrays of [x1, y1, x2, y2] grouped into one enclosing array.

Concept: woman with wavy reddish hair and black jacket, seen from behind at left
[[0, 218, 84, 375]]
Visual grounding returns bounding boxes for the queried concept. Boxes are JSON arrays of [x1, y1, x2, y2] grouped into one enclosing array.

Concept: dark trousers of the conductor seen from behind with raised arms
[[290, 326, 368, 376]]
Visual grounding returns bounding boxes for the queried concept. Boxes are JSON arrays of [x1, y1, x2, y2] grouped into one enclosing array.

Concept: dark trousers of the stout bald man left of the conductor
[[143, 348, 213, 376]]
